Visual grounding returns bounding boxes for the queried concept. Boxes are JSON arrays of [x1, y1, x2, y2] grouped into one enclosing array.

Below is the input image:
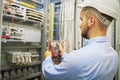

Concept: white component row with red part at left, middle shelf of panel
[[2, 26, 41, 42]]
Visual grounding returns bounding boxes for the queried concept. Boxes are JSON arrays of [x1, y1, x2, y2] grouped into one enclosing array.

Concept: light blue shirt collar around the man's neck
[[84, 36, 108, 46]]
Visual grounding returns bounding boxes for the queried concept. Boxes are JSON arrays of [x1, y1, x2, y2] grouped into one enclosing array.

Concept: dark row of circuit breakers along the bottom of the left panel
[[0, 65, 41, 80]]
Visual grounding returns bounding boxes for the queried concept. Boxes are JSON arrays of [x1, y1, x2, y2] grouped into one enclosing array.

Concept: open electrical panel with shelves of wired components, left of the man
[[0, 0, 44, 80]]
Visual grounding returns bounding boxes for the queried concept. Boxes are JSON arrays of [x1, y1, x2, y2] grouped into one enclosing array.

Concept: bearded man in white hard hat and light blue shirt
[[42, 0, 118, 80]]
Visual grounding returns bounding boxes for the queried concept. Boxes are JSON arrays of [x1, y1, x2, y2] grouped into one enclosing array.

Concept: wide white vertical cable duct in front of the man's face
[[60, 0, 75, 52]]
